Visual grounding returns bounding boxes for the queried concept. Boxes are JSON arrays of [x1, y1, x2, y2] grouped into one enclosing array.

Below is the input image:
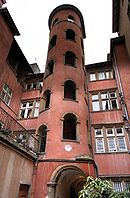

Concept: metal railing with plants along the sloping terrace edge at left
[[0, 107, 39, 154]]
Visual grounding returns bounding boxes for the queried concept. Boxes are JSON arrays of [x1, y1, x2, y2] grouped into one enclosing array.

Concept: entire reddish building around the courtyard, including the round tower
[[0, 0, 130, 198]]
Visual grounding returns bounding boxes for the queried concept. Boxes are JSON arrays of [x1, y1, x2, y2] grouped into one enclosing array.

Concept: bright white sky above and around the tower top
[[5, 0, 116, 72]]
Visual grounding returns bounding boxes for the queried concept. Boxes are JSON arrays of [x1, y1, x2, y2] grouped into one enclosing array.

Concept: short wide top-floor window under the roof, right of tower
[[89, 70, 113, 81]]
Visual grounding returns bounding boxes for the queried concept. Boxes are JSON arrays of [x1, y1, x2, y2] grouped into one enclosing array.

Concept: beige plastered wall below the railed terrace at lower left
[[0, 144, 34, 198]]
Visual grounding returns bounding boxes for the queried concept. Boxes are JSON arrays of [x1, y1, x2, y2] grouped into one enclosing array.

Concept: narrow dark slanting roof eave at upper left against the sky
[[0, 8, 20, 36]]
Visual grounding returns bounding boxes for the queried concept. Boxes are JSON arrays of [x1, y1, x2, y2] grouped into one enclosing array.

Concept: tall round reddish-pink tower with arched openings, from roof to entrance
[[35, 4, 95, 198]]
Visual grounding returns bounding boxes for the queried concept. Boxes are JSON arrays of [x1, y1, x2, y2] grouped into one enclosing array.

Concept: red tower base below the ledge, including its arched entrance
[[32, 157, 97, 198]]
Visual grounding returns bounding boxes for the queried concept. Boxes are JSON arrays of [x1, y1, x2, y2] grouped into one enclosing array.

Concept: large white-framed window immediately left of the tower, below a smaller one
[[19, 100, 40, 118]]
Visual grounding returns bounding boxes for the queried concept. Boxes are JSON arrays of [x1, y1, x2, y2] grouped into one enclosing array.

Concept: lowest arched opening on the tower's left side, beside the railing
[[38, 125, 47, 152]]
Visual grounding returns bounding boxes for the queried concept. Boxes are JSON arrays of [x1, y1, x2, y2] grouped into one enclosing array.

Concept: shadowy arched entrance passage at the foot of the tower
[[49, 166, 85, 198]]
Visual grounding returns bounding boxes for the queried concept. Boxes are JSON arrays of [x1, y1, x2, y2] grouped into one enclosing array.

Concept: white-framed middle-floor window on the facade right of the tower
[[92, 91, 119, 111]]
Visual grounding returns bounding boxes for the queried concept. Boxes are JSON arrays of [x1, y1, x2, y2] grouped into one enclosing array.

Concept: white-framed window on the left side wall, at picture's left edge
[[0, 83, 13, 106]]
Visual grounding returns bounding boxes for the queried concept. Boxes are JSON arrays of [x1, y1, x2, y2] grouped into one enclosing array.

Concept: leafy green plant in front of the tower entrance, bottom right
[[78, 176, 129, 198]]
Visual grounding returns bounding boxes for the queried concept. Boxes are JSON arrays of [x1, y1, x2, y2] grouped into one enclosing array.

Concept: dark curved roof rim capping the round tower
[[48, 4, 86, 38]]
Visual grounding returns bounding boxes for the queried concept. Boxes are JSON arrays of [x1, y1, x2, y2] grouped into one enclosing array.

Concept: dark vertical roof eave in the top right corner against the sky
[[112, 0, 120, 32]]
